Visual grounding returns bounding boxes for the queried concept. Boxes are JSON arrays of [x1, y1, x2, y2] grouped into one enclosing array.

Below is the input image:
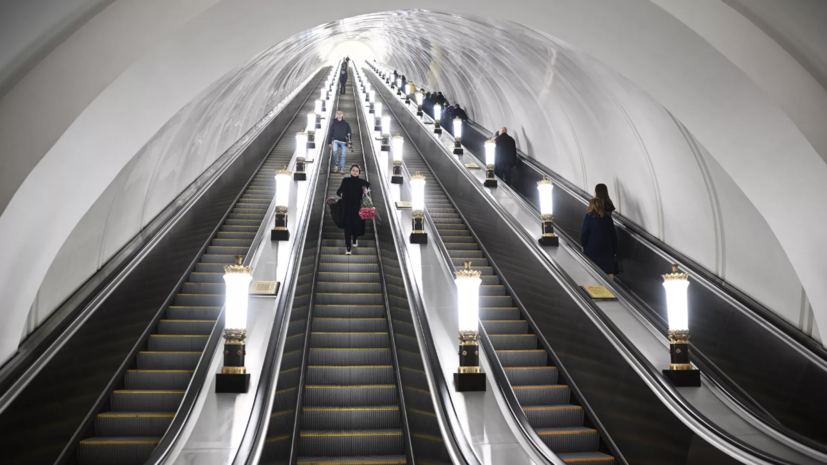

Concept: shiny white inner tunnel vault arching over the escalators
[[0, 2, 825, 358]]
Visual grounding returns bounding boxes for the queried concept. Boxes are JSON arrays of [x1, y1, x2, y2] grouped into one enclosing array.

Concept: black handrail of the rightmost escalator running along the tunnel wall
[[466, 120, 827, 371]]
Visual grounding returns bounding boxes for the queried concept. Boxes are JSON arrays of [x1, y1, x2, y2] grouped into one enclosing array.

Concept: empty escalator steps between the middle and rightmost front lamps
[[403, 136, 614, 464]]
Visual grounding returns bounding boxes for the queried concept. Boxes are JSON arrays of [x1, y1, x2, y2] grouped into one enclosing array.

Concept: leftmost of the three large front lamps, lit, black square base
[[215, 255, 253, 393]]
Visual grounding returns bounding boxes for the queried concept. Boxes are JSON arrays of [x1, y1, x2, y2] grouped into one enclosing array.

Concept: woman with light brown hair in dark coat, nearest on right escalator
[[580, 199, 617, 278]]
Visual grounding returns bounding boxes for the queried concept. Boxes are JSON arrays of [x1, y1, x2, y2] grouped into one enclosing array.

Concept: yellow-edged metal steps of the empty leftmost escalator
[[78, 130, 298, 465]]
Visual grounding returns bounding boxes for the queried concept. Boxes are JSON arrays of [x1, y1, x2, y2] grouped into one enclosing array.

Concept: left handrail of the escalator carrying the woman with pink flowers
[[232, 62, 338, 465]]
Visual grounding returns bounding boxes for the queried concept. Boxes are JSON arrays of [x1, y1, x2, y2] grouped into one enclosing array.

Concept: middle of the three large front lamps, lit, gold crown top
[[454, 261, 485, 392]]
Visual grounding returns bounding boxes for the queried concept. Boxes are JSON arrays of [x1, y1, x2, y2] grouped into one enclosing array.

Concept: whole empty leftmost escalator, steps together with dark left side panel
[[0, 65, 334, 465]]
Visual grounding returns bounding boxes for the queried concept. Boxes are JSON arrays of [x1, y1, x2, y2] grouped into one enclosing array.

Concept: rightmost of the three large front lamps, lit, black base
[[663, 265, 701, 387]]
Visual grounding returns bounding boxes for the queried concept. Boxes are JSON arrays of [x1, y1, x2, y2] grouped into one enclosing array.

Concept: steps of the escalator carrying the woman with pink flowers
[[262, 67, 409, 465]]
